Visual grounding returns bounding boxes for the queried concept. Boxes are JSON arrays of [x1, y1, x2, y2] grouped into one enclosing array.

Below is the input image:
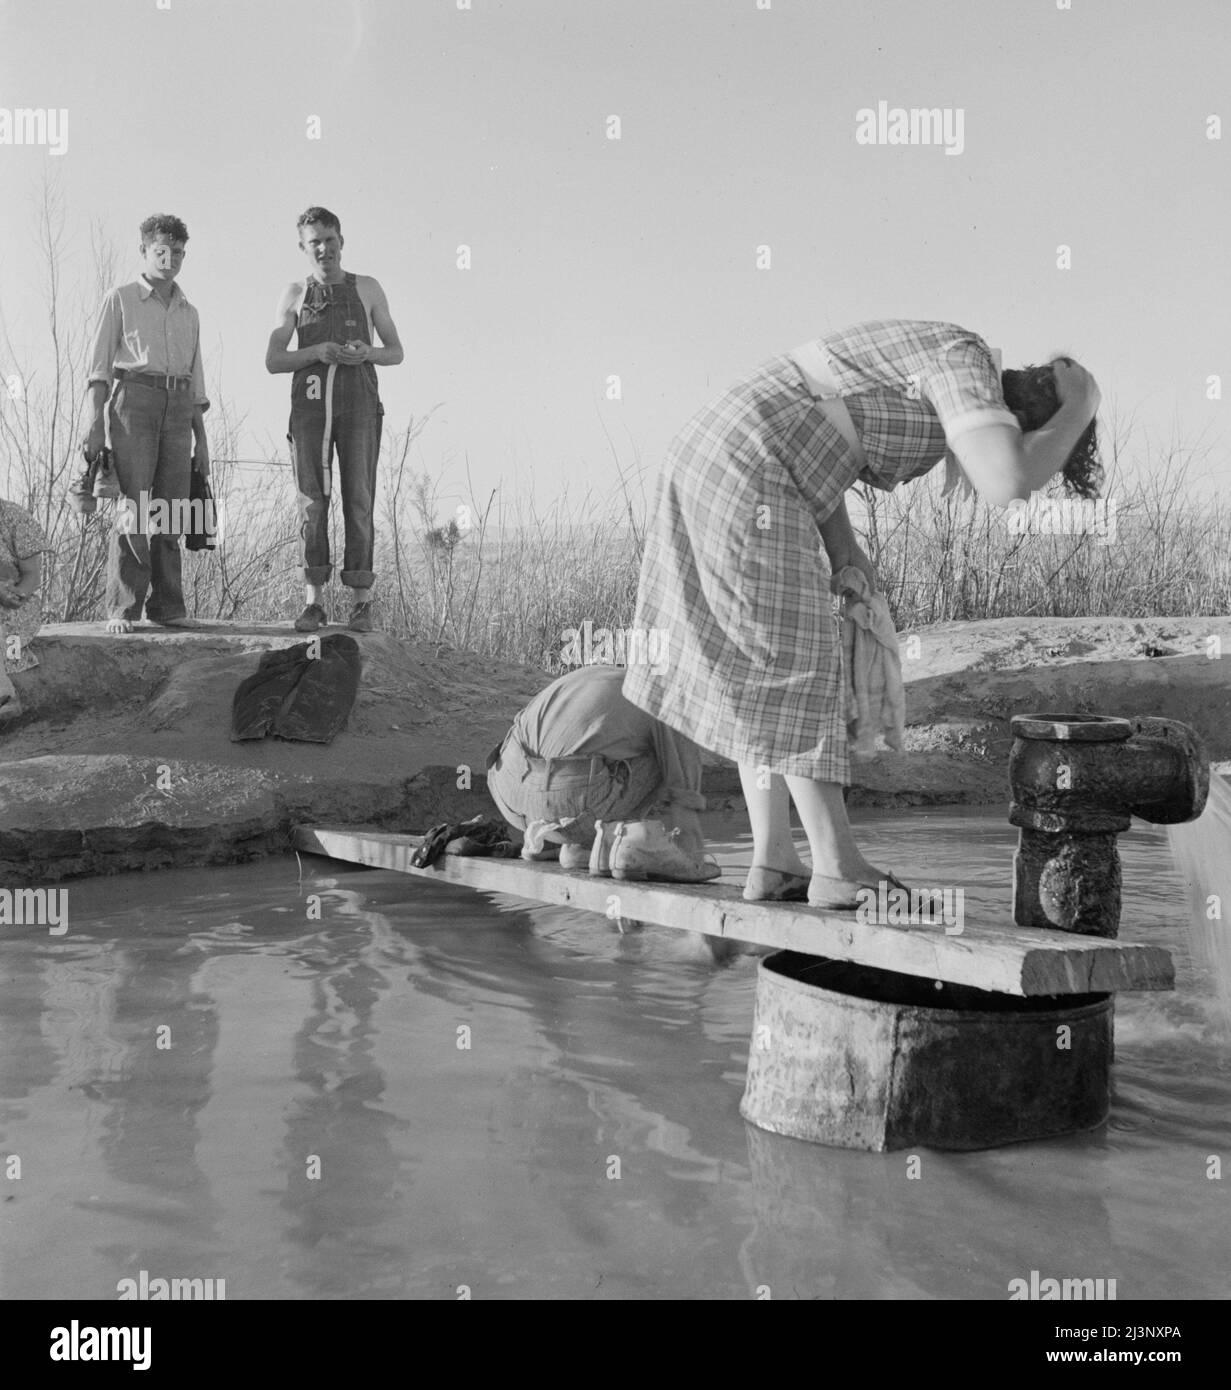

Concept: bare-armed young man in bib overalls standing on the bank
[[265, 207, 403, 632]]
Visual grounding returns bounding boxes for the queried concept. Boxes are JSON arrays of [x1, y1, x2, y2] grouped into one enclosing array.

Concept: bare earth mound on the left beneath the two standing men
[[0, 624, 549, 883]]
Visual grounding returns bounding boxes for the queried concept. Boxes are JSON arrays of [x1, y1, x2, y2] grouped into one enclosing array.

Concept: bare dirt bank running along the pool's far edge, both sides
[[0, 619, 1231, 883]]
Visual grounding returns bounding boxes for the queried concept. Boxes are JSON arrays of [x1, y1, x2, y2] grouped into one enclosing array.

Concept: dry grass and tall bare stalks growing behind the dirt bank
[[0, 185, 1231, 671]]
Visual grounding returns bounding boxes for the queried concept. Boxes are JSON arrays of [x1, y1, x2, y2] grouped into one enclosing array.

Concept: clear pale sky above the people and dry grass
[[0, 0, 1231, 517]]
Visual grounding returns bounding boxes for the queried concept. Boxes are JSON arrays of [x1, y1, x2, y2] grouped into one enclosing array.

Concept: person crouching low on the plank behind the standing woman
[[488, 666, 721, 883]]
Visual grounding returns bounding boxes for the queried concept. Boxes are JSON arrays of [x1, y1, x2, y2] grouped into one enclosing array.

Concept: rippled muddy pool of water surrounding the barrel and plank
[[0, 810, 1231, 1300]]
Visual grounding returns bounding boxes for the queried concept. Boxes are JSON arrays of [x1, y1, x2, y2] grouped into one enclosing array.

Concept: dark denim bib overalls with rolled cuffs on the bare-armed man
[[286, 274, 385, 589]]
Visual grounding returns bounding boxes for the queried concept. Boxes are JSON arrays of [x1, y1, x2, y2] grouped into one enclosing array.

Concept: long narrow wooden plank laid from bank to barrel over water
[[293, 826, 1175, 995]]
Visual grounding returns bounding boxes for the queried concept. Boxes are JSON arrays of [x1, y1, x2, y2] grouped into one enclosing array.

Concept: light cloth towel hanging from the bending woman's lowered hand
[[829, 564, 906, 758]]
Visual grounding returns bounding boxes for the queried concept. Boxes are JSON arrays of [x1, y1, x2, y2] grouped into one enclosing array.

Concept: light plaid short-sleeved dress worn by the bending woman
[[624, 320, 1017, 785]]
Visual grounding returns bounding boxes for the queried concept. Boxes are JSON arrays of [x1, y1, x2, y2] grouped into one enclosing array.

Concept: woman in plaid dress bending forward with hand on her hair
[[622, 320, 1102, 909]]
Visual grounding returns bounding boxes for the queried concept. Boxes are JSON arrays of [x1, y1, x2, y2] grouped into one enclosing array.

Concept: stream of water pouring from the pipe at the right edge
[[1167, 771, 1231, 1034]]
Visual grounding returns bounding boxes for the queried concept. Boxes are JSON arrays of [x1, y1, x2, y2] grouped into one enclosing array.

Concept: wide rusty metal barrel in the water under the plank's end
[[739, 951, 1114, 1151]]
